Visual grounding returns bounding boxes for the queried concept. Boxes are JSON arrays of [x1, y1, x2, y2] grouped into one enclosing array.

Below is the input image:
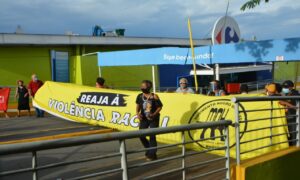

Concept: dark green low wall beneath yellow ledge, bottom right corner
[[245, 151, 300, 180]]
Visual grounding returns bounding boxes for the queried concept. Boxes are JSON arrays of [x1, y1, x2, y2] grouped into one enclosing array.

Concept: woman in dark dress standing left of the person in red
[[15, 80, 30, 117]]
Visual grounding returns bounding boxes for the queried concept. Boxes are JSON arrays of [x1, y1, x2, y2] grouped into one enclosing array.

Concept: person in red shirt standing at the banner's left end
[[28, 74, 44, 117]]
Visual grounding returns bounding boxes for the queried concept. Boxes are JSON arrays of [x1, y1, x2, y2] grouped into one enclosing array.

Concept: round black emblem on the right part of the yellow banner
[[188, 99, 247, 148]]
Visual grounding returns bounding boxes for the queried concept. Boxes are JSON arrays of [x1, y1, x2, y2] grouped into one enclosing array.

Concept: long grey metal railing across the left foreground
[[0, 120, 231, 180]]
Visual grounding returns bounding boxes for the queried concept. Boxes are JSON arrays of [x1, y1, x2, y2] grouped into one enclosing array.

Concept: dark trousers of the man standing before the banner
[[139, 120, 159, 158]]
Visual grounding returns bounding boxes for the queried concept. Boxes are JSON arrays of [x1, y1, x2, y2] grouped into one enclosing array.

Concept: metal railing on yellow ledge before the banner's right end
[[232, 96, 300, 165]]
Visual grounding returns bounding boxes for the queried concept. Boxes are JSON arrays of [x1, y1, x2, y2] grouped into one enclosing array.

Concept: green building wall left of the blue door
[[0, 46, 72, 85]]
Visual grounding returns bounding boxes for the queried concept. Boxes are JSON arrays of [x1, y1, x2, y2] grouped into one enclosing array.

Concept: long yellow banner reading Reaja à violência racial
[[33, 82, 288, 159]]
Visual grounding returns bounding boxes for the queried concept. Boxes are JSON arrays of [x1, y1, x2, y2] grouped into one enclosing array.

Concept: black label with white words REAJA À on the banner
[[77, 92, 128, 106]]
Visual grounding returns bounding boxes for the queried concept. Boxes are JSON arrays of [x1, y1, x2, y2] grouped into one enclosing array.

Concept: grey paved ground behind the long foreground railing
[[0, 114, 225, 180]]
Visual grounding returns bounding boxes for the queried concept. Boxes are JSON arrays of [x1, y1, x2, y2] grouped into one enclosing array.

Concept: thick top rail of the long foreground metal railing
[[0, 120, 232, 155]]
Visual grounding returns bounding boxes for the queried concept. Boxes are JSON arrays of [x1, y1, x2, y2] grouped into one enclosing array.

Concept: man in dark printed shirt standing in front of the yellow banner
[[136, 80, 163, 161]]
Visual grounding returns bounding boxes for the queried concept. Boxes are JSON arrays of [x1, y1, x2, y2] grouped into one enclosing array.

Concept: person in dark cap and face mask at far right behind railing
[[280, 80, 299, 146]]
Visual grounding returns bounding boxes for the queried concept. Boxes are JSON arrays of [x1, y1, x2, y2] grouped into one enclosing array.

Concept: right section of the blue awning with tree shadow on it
[[210, 38, 300, 64]]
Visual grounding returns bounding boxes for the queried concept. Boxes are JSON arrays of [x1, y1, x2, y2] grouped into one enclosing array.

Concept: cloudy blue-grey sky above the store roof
[[0, 0, 300, 40]]
